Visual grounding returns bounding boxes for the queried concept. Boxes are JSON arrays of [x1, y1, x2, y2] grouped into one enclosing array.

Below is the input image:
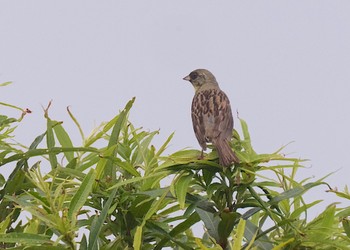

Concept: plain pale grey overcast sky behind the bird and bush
[[0, 0, 350, 210]]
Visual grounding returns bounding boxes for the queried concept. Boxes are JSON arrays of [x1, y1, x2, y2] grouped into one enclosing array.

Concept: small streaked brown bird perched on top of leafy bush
[[183, 69, 239, 167]]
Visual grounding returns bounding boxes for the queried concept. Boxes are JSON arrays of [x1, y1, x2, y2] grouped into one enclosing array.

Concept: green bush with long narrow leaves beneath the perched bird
[[0, 84, 350, 249]]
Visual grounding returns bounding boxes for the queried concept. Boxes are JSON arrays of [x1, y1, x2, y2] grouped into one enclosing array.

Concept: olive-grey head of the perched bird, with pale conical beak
[[183, 69, 218, 91]]
